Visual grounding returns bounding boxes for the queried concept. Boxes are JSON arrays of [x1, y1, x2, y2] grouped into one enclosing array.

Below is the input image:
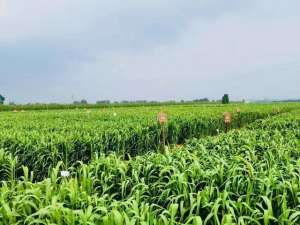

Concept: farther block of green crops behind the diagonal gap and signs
[[0, 104, 298, 180]]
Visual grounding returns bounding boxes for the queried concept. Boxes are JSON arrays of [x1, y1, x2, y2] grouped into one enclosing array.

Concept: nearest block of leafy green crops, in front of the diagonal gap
[[0, 106, 300, 225]]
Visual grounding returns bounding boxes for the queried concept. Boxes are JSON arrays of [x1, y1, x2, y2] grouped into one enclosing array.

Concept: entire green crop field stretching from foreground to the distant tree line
[[0, 103, 300, 225]]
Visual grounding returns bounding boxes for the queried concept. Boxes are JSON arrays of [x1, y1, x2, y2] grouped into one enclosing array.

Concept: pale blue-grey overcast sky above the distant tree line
[[0, 0, 300, 103]]
